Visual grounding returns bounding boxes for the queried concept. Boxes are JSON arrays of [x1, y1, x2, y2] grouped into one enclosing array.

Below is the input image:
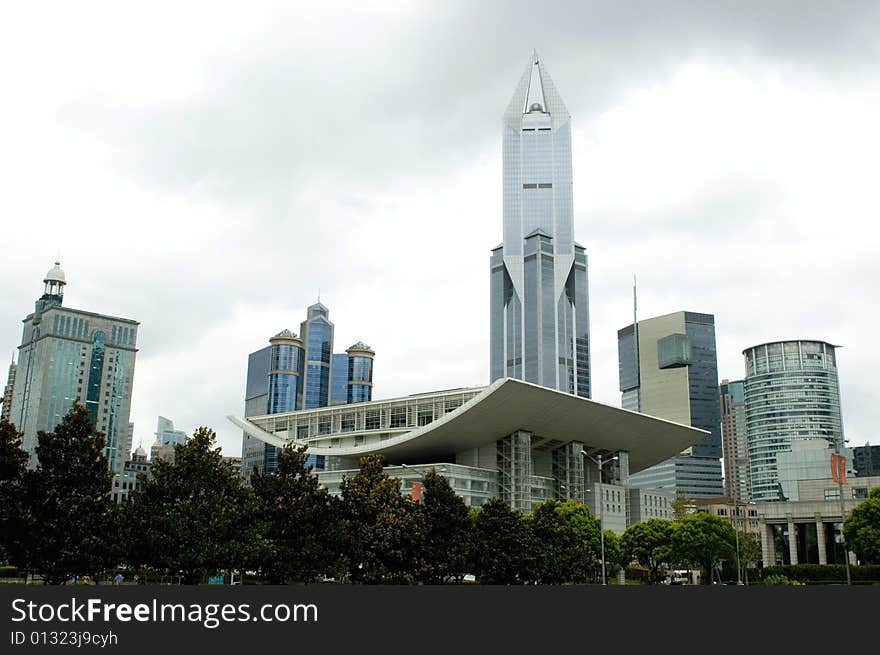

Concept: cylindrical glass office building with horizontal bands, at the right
[[743, 340, 851, 501]]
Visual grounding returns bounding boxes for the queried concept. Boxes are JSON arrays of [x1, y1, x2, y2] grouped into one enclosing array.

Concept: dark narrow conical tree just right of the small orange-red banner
[[420, 468, 474, 584]]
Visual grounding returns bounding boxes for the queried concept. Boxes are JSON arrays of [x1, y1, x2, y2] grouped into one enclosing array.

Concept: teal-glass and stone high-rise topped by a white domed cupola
[[10, 262, 138, 472]]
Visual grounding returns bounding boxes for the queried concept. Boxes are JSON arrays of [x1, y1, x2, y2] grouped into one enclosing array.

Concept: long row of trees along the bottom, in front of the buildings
[[0, 405, 880, 584]]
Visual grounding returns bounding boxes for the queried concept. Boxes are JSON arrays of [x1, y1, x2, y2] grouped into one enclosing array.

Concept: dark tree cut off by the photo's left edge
[[0, 419, 33, 568]]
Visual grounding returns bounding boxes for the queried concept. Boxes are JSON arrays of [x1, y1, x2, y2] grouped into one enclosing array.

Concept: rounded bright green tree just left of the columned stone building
[[672, 512, 736, 584]]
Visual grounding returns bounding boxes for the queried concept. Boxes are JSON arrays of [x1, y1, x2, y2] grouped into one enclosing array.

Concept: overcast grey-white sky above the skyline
[[0, 0, 880, 455]]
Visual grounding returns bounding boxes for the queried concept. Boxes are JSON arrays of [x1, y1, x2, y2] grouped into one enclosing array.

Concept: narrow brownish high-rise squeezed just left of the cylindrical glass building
[[719, 380, 750, 501]]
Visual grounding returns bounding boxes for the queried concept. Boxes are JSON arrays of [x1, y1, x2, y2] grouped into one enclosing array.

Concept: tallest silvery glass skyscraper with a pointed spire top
[[490, 53, 590, 398]]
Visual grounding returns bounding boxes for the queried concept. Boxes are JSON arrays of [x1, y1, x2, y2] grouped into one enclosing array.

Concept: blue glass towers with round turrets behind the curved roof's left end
[[241, 302, 376, 481]]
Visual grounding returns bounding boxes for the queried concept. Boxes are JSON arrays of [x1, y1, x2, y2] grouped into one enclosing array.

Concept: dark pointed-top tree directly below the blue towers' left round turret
[[251, 444, 341, 584]]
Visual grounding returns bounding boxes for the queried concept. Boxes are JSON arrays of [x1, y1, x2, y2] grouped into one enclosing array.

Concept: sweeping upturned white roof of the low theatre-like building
[[227, 378, 708, 473]]
